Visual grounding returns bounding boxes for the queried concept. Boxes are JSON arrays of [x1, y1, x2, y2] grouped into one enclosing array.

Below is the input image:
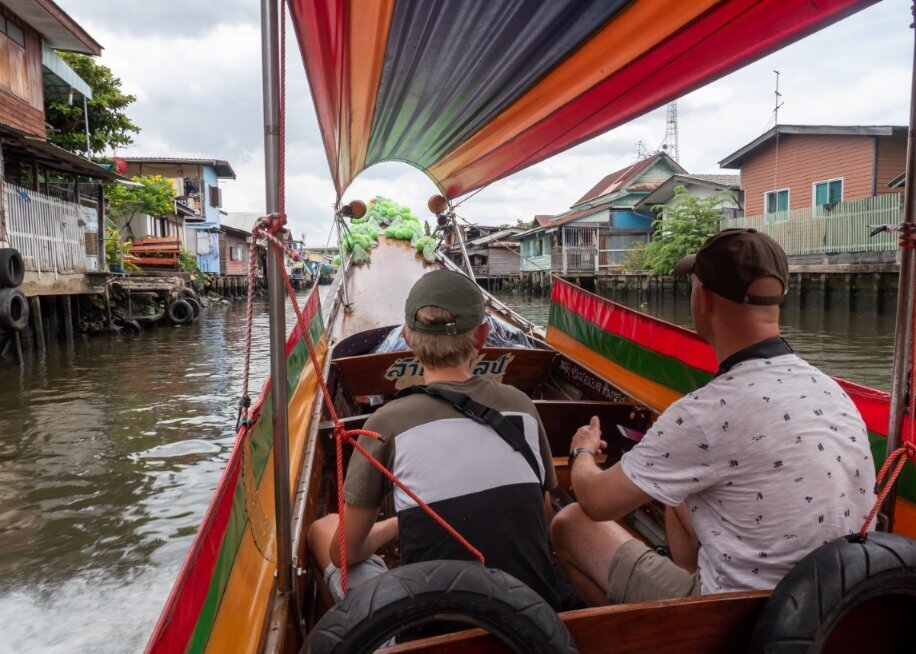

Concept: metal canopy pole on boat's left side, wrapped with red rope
[[261, 0, 293, 595]]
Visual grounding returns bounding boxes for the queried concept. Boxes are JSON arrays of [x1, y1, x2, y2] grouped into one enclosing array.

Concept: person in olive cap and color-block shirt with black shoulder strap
[[309, 270, 560, 608]]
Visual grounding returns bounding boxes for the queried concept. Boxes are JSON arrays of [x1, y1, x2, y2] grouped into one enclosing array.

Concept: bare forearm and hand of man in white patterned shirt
[[570, 416, 652, 521]]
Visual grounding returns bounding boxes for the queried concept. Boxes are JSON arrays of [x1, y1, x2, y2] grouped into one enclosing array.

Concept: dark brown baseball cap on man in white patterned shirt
[[674, 228, 789, 305]]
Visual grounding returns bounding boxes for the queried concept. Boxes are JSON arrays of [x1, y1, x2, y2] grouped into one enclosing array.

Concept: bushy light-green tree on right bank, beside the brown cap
[[646, 186, 731, 275]]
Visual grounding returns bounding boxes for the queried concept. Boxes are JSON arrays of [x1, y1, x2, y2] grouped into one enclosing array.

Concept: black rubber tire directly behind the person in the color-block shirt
[[300, 561, 578, 654]]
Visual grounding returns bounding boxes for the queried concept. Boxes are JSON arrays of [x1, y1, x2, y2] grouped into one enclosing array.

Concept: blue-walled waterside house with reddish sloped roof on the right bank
[[517, 152, 686, 286]]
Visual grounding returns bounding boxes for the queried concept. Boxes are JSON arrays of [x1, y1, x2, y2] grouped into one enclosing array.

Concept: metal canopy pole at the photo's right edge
[[879, 5, 916, 531]]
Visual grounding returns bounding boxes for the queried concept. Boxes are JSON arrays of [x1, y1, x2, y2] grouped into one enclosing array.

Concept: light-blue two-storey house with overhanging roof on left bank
[[124, 157, 235, 275]]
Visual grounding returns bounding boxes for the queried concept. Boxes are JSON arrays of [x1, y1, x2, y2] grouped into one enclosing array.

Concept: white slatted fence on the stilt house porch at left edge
[[3, 183, 86, 277]]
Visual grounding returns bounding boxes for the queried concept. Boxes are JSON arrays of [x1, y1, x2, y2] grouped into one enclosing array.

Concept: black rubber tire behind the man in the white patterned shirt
[[748, 532, 916, 654]]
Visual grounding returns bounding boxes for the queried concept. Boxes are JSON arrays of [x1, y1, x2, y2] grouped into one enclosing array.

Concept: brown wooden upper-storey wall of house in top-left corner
[[0, 5, 45, 137]]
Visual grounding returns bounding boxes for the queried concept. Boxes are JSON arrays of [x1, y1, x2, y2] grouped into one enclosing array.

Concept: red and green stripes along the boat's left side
[[146, 287, 324, 654]]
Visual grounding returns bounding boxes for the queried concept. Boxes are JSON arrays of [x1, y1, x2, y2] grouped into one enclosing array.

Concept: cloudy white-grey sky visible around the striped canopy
[[57, 0, 913, 244]]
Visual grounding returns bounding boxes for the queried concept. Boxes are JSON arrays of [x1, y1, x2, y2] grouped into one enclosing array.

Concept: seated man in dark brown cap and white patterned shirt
[[551, 229, 875, 605]]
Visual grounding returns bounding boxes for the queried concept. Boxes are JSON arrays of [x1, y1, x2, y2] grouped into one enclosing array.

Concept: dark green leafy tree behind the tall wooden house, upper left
[[45, 52, 140, 155]]
